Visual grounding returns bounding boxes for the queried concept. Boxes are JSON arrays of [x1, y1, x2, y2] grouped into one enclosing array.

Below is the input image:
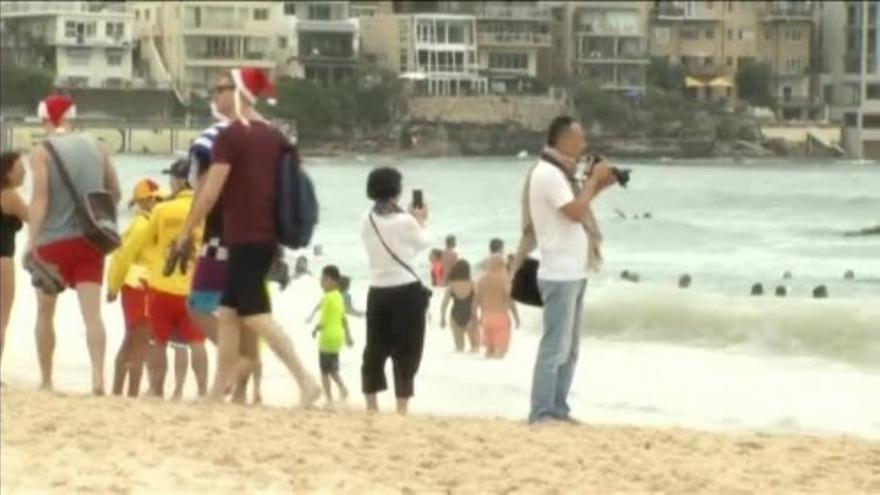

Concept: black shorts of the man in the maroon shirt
[[220, 243, 278, 316]]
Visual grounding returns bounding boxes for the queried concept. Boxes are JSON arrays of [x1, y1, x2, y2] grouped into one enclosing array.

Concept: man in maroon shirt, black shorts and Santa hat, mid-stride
[[177, 68, 321, 406]]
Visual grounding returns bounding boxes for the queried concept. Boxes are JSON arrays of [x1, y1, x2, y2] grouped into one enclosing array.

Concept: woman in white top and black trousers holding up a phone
[[361, 168, 430, 414]]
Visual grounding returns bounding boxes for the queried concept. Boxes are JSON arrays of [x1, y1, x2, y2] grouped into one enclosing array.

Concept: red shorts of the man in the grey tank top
[[37, 237, 104, 288]]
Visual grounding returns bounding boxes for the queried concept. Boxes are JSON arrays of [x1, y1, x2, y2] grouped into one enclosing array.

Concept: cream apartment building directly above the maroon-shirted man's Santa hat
[[127, 1, 283, 102]]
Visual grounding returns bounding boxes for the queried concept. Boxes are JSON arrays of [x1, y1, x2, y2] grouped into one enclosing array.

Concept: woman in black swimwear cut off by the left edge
[[0, 152, 27, 384]]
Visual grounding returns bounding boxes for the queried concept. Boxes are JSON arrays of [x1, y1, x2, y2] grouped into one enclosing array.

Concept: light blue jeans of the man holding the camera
[[529, 280, 587, 423]]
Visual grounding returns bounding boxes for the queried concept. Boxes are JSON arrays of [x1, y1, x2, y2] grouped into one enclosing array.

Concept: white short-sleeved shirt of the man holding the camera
[[529, 160, 589, 282]]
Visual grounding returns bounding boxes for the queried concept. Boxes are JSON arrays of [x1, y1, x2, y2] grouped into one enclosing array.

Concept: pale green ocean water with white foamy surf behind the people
[[3, 156, 880, 438]]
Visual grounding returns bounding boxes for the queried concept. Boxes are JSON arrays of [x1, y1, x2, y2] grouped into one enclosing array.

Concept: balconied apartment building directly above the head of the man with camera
[[571, 2, 650, 94]]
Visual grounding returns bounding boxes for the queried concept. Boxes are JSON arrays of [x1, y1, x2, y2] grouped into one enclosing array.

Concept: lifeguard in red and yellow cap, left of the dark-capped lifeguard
[[107, 179, 159, 397]]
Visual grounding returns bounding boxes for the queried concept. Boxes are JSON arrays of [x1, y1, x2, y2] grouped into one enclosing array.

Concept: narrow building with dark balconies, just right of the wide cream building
[[282, 1, 358, 84]]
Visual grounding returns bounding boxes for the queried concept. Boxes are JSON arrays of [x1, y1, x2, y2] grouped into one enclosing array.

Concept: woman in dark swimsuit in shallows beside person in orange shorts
[[440, 260, 480, 352]]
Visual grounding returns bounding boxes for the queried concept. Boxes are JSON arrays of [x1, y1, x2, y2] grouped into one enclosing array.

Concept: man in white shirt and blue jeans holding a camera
[[524, 116, 617, 424]]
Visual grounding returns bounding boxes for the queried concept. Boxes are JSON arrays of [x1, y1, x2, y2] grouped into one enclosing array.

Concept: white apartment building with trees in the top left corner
[[0, 1, 134, 88]]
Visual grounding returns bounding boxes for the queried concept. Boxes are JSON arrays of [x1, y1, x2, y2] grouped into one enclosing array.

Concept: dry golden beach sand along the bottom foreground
[[0, 389, 880, 495]]
